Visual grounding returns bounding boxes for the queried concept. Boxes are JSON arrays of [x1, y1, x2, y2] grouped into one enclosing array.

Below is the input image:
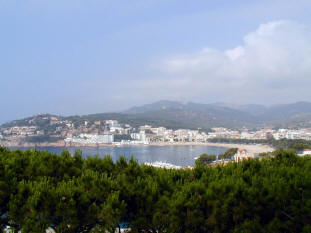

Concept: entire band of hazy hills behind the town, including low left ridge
[[2, 100, 311, 129]]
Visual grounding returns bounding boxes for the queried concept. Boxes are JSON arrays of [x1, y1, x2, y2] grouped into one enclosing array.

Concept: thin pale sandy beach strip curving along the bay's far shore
[[0, 141, 275, 154]]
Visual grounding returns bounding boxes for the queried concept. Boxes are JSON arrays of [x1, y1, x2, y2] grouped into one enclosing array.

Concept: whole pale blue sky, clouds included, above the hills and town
[[0, 0, 311, 124]]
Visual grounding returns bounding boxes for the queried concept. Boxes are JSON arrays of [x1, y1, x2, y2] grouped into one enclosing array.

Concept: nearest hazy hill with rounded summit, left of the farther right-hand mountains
[[125, 101, 256, 128]]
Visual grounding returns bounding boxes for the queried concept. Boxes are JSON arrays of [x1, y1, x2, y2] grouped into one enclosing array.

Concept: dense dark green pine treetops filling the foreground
[[0, 148, 311, 233]]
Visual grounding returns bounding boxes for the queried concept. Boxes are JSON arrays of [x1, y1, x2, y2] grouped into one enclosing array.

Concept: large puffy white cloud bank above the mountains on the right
[[147, 21, 311, 102]]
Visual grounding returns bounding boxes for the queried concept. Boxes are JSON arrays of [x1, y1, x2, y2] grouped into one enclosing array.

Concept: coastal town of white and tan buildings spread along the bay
[[0, 115, 311, 146]]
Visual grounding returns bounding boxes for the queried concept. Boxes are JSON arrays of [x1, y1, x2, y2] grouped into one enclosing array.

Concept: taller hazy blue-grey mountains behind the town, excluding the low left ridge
[[125, 100, 311, 128]]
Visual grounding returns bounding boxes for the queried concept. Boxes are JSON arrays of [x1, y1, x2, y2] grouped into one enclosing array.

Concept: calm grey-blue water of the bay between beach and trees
[[12, 145, 227, 166]]
